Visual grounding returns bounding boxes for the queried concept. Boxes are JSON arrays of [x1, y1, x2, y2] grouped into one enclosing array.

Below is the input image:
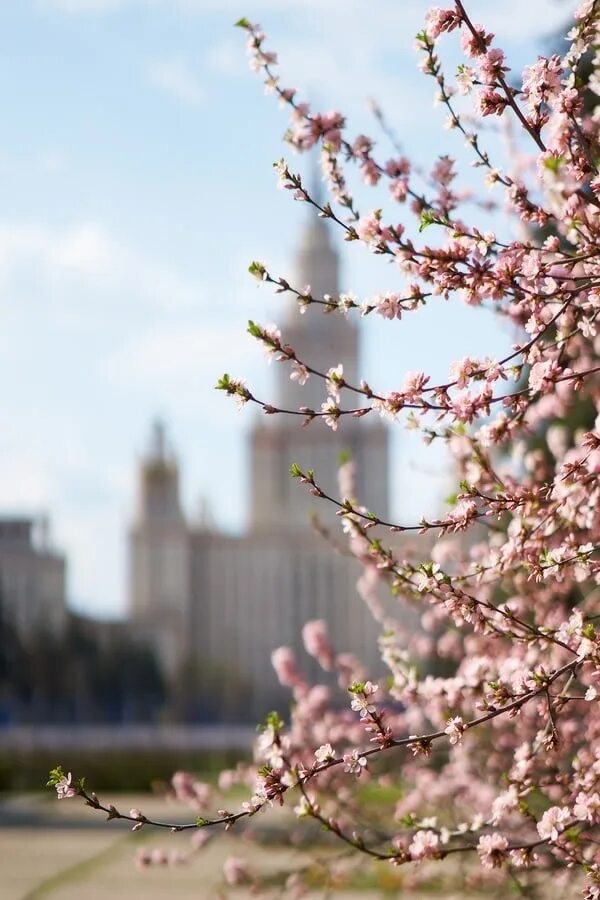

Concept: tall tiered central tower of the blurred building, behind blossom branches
[[250, 211, 389, 531]]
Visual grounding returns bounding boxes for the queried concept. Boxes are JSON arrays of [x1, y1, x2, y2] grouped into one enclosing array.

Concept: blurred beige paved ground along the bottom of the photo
[[0, 792, 580, 900]]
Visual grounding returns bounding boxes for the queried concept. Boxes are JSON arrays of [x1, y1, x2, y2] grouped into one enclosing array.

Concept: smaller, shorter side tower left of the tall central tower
[[129, 422, 191, 673]]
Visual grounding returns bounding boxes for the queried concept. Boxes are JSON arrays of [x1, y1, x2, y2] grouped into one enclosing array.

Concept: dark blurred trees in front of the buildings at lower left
[[0, 597, 254, 727]]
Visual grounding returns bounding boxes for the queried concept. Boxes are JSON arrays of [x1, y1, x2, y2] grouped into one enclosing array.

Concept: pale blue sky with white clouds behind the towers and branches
[[0, 0, 572, 616]]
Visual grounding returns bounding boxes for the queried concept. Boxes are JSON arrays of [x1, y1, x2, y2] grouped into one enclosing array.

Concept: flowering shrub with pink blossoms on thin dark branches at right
[[51, 0, 600, 900]]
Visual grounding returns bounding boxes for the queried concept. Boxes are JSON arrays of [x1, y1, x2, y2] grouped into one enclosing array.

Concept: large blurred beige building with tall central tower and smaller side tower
[[130, 209, 389, 717]]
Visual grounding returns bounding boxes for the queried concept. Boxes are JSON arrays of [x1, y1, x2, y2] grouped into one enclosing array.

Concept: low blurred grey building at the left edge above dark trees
[[0, 516, 67, 641]]
